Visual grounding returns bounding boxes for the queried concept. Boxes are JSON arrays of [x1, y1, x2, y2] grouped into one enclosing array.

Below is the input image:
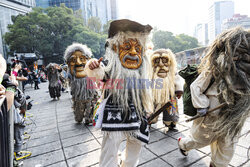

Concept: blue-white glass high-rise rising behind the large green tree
[[36, 0, 117, 24]]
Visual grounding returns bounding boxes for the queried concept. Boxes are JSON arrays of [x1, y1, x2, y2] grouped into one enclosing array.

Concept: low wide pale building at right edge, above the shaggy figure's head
[[221, 14, 250, 31]]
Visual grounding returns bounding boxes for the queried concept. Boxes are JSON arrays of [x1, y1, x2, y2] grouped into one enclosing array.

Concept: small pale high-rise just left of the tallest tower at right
[[194, 23, 208, 46]]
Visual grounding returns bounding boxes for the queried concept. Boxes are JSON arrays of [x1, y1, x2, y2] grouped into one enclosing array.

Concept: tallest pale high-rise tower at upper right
[[208, 1, 234, 43]]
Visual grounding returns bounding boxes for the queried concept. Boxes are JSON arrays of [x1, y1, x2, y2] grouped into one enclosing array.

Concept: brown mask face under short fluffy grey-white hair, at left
[[69, 51, 88, 78]]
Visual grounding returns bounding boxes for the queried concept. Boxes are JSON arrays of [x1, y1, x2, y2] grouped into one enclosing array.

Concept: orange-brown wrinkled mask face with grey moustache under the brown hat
[[119, 38, 142, 69]]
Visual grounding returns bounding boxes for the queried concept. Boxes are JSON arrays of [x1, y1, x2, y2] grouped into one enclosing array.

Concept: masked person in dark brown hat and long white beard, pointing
[[86, 19, 152, 167]]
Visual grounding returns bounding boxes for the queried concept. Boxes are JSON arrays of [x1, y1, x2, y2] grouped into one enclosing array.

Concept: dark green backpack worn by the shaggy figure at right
[[179, 64, 214, 116]]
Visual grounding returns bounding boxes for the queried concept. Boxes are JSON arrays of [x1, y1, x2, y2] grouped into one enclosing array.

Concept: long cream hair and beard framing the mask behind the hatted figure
[[151, 49, 177, 104]]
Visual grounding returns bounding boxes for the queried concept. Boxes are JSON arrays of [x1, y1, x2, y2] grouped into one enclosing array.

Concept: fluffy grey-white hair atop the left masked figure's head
[[64, 43, 92, 62]]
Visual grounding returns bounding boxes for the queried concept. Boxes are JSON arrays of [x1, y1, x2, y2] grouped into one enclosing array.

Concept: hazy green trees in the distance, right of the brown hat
[[153, 30, 199, 53]]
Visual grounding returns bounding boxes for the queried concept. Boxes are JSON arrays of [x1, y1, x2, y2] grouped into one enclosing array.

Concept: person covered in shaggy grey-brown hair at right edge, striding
[[178, 27, 250, 167]]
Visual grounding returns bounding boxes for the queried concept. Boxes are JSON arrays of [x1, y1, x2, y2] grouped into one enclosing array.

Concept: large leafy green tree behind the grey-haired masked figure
[[4, 5, 106, 64]]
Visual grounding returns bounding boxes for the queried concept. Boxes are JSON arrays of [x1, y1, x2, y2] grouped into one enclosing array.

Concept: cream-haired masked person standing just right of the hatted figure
[[151, 49, 184, 132]]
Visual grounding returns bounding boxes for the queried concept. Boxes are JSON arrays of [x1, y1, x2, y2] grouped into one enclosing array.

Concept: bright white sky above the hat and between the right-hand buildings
[[117, 0, 250, 35]]
